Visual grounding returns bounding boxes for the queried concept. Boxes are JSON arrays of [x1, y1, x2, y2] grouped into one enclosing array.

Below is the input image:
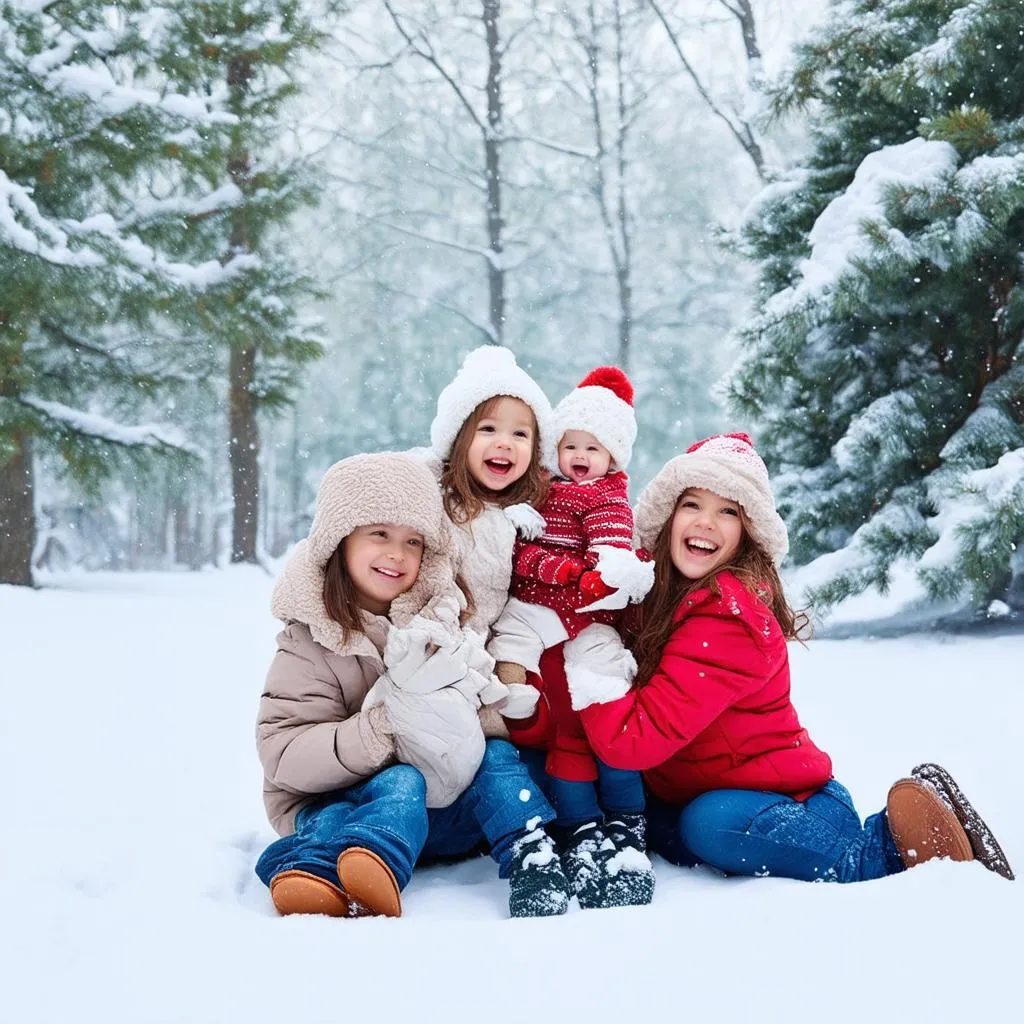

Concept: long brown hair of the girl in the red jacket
[[633, 495, 811, 686]]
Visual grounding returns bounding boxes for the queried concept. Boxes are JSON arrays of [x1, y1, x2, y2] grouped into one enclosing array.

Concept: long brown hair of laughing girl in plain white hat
[[441, 394, 551, 523]]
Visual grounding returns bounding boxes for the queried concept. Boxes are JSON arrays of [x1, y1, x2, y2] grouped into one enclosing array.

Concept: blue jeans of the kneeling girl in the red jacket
[[647, 779, 904, 882]]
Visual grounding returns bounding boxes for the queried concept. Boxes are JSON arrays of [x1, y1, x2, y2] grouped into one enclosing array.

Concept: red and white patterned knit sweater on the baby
[[510, 473, 633, 638]]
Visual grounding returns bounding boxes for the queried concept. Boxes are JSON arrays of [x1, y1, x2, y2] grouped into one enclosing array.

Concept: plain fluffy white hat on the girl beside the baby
[[430, 345, 551, 459]]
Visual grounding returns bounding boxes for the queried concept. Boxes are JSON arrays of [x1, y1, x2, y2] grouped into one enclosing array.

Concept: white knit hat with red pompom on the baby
[[548, 367, 637, 469]]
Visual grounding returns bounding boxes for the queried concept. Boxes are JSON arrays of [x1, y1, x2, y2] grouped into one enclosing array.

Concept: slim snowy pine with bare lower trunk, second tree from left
[[152, 0, 330, 562]]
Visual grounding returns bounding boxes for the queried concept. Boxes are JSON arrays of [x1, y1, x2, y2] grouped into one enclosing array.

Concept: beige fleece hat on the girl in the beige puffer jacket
[[308, 452, 446, 568]]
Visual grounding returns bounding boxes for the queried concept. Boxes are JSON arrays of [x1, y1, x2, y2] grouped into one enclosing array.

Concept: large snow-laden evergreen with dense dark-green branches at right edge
[[728, 0, 1024, 606]]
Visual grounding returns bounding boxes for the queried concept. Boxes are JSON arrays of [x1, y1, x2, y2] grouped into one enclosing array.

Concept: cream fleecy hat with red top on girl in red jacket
[[636, 434, 790, 565]]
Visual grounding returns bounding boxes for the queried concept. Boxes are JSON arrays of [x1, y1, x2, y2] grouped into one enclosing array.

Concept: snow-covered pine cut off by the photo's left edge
[[0, 0, 237, 584]]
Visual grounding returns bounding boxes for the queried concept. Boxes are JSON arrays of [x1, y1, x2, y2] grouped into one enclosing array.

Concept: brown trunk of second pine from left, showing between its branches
[[227, 54, 260, 562]]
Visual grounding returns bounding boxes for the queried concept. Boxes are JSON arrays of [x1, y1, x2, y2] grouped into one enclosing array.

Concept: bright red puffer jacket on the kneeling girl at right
[[582, 572, 831, 806]]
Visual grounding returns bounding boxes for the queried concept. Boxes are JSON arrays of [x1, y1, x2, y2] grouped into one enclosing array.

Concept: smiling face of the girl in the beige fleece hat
[[344, 522, 423, 615]]
